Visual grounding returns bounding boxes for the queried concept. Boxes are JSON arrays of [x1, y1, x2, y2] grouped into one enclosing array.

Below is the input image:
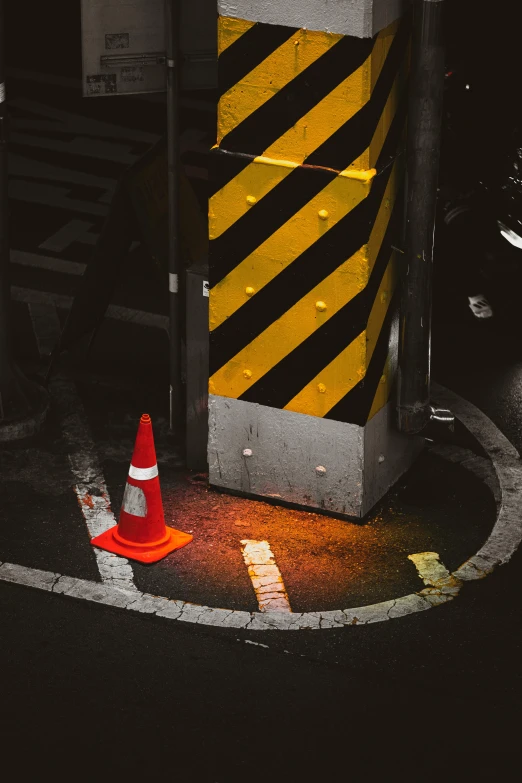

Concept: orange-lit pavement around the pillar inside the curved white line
[[0, 373, 506, 632]]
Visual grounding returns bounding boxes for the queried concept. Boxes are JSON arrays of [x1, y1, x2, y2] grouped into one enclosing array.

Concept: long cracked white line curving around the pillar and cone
[[0, 384, 522, 631]]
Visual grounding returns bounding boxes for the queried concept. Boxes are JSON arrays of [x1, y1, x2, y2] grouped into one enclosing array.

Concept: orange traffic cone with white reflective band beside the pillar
[[91, 413, 193, 563]]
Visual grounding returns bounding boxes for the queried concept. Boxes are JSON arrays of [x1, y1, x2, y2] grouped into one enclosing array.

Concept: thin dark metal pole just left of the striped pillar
[[165, 0, 184, 448]]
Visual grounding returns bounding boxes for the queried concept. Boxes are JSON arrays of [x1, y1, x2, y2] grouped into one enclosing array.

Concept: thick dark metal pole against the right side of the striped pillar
[[398, 0, 444, 434]]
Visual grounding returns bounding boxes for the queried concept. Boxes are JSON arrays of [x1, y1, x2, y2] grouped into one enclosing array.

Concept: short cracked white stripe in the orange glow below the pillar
[[241, 539, 292, 612]]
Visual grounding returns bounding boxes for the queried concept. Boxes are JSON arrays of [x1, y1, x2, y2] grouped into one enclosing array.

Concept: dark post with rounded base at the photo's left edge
[[0, 0, 49, 441]]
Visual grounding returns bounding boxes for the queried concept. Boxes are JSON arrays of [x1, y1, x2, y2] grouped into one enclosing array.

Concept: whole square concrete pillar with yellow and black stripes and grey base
[[208, 0, 422, 517]]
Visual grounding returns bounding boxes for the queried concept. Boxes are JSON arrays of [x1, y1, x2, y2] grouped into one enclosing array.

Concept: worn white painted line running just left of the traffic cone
[[49, 375, 136, 591]]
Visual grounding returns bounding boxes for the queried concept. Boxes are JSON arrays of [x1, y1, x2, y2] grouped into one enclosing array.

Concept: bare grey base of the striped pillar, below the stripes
[[208, 395, 423, 518]]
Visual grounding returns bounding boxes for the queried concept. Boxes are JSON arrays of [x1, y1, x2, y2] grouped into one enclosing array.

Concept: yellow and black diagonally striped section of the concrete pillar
[[209, 9, 410, 424]]
